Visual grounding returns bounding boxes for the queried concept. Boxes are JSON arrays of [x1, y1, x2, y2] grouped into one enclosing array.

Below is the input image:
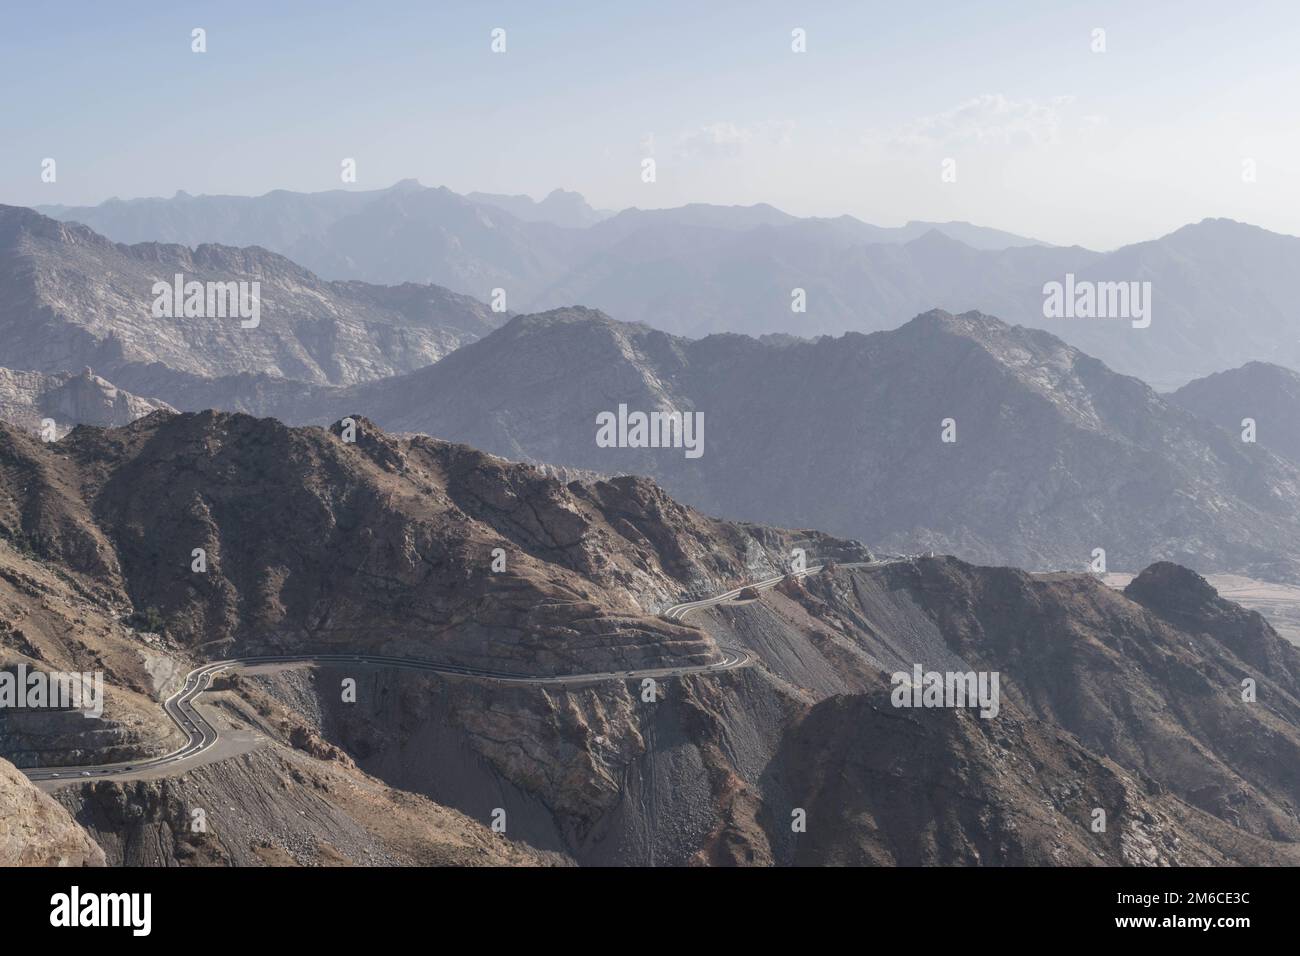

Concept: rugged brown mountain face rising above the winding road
[[0, 412, 865, 674]]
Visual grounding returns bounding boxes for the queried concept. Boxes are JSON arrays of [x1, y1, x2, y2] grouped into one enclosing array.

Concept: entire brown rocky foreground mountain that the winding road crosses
[[0, 412, 1300, 865]]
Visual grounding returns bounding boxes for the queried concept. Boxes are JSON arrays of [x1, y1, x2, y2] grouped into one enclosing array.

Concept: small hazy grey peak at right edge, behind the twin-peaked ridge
[[1169, 362, 1300, 462]]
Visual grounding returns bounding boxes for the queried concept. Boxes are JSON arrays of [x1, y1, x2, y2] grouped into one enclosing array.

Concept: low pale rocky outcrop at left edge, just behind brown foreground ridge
[[0, 368, 174, 437]]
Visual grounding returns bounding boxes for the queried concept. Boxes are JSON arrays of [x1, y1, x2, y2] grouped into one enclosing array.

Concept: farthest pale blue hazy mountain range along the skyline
[[35, 181, 1300, 389]]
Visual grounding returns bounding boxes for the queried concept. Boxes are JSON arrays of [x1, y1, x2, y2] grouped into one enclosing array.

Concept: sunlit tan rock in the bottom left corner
[[0, 760, 104, 866]]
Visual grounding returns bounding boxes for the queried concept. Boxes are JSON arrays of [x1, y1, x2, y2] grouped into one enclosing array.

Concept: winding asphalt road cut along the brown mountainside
[[22, 562, 867, 780]]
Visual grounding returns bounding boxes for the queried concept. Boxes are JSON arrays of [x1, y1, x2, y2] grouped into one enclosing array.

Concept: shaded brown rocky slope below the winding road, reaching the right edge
[[245, 559, 1300, 865]]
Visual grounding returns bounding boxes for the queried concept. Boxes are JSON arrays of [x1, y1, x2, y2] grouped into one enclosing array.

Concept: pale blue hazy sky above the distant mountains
[[0, 0, 1300, 248]]
